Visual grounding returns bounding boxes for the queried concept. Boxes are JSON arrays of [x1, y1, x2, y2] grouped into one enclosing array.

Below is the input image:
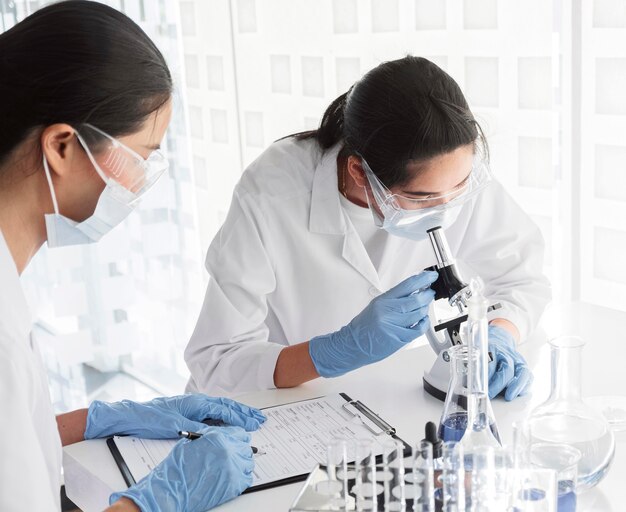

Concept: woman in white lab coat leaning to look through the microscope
[[185, 56, 550, 400]]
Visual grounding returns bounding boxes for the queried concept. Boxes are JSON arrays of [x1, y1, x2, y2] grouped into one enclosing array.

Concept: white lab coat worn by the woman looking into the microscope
[[185, 138, 550, 394]]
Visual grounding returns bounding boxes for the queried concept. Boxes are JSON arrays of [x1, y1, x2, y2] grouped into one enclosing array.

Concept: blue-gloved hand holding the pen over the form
[[109, 426, 254, 512]]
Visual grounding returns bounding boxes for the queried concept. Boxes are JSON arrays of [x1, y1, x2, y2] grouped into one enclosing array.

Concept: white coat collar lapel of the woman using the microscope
[[309, 144, 380, 289]]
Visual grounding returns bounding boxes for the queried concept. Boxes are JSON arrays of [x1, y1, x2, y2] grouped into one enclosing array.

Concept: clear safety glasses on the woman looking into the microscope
[[361, 144, 492, 218]]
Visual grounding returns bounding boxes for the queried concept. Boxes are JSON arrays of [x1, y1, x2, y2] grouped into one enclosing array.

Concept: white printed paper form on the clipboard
[[109, 394, 388, 486]]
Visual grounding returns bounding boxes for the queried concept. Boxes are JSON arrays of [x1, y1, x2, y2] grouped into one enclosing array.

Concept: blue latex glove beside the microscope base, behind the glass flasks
[[489, 325, 533, 401]]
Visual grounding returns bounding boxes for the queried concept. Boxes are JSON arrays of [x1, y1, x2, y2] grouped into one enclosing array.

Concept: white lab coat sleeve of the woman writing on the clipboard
[[0, 340, 61, 512]]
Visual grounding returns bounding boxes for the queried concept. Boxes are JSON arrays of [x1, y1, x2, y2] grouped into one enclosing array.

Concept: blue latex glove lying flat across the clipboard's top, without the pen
[[85, 393, 265, 439]]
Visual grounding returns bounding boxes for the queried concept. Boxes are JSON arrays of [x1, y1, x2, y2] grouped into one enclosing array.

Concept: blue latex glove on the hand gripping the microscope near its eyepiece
[[309, 272, 437, 377]]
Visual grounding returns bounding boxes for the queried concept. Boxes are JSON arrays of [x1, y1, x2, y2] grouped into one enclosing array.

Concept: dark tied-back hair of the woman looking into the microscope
[[295, 56, 487, 187]]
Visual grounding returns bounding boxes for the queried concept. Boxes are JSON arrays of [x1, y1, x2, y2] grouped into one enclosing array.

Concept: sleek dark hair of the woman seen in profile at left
[[0, 0, 172, 163]]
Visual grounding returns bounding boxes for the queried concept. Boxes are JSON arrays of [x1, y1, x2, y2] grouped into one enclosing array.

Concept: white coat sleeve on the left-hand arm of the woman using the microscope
[[185, 189, 284, 394]]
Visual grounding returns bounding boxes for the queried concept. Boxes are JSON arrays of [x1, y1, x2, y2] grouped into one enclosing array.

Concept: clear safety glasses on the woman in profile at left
[[76, 124, 169, 199]]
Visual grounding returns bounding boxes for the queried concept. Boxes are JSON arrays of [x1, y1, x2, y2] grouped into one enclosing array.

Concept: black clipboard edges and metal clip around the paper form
[[106, 393, 411, 494]]
